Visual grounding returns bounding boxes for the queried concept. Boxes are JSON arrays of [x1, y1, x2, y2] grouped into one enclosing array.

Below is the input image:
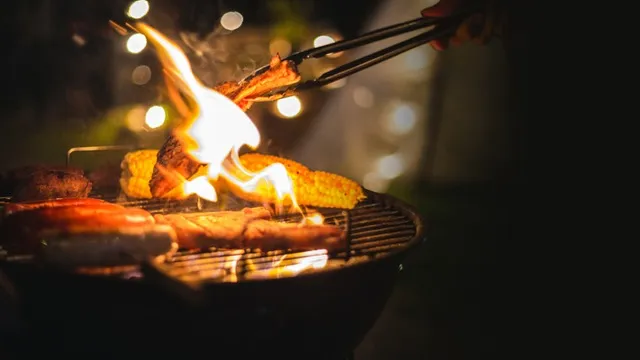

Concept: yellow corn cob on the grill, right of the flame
[[227, 153, 366, 209]]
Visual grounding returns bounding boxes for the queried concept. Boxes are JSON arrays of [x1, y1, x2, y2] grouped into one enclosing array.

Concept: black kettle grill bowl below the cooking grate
[[3, 190, 423, 359]]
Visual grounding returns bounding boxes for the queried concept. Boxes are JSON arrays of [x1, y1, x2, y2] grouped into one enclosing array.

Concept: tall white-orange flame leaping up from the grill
[[136, 23, 299, 209]]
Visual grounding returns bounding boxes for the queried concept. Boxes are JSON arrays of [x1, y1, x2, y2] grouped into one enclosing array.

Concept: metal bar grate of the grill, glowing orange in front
[[105, 193, 418, 282]]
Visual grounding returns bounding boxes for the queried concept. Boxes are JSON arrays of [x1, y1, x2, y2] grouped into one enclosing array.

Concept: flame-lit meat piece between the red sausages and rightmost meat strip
[[155, 208, 271, 249]]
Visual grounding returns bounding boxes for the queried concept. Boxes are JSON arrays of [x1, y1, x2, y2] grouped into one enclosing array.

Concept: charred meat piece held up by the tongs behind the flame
[[149, 55, 300, 197]]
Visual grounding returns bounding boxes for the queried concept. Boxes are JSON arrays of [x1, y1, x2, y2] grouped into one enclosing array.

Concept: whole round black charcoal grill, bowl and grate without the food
[[3, 192, 424, 359]]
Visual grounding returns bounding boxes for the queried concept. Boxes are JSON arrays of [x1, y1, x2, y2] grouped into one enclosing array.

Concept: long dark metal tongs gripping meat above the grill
[[248, 8, 480, 102]]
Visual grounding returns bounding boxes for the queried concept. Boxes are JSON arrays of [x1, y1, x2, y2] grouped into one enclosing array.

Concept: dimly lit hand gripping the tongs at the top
[[421, 0, 493, 51]]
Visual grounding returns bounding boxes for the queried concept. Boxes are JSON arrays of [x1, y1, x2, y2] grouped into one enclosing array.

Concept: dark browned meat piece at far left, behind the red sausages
[[12, 167, 92, 202]]
